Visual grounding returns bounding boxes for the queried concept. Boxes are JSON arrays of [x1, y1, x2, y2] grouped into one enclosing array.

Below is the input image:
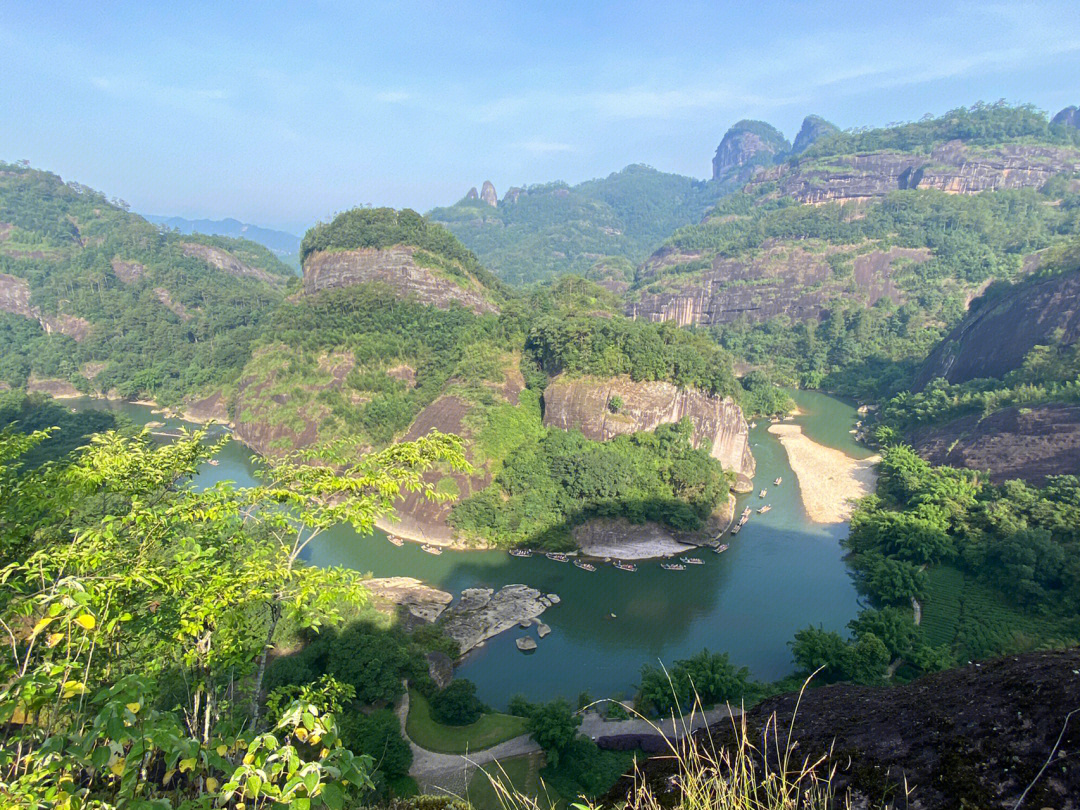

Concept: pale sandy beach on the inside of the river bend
[[769, 424, 881, 523]]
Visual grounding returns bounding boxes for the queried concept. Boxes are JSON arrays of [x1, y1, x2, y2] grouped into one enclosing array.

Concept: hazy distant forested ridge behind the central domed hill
[[428, 165, 727, 284]]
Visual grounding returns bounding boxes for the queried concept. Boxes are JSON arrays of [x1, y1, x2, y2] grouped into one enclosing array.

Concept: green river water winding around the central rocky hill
[[71, 391, 868, 708]]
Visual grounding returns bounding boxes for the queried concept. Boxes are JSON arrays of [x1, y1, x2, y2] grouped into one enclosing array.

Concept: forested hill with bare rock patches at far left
[[0, 164, 295, 402]]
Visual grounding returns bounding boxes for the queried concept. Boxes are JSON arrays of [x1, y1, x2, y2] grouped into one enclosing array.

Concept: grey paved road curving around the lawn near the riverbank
[[396, 692, 741, 798]]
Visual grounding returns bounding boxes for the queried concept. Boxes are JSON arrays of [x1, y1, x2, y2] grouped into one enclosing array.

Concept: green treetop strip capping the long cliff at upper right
[[801, 102, 1080, 159]]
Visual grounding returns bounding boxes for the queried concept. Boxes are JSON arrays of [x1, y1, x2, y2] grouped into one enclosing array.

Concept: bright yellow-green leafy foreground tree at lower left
[[0, 431, 468, 807]]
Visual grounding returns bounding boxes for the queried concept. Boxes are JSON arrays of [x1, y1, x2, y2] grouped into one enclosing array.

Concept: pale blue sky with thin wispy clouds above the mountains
[[6, 0, 1080, 233]]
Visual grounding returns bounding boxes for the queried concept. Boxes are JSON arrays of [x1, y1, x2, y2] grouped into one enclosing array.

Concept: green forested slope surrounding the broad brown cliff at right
[[652, 184, 1080, 397]]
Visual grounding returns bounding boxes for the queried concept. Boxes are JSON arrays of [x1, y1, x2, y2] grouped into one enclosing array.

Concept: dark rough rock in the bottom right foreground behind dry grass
[[613, 649, 1080, 810]]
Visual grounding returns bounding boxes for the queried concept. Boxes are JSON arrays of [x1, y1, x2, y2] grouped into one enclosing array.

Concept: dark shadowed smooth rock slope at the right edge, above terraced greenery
[[914, 270, 1080, 391]]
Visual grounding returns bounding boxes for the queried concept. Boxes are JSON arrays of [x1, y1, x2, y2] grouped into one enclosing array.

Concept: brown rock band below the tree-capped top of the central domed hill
[[295, 245, 499, 314]]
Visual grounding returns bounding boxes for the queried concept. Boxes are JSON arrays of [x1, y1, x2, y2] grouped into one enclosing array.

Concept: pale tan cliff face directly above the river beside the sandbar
[[543, 377, 755, 486]]
